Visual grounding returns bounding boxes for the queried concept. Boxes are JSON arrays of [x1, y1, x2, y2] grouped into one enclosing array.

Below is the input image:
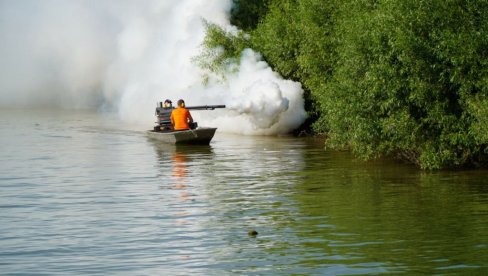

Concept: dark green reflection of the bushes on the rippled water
[[294, 144, 488, 274]]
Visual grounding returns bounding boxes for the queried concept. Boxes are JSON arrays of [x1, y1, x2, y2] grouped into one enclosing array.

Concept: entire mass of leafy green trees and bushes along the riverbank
[[198, 0, 488, 169]]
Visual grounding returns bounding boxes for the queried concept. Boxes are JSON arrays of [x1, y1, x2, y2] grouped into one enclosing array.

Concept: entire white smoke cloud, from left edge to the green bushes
[[0, 0, 306, 135]]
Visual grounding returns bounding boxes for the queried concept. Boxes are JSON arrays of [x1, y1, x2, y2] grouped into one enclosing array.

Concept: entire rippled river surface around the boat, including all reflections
[[0, 110, 488, 275]]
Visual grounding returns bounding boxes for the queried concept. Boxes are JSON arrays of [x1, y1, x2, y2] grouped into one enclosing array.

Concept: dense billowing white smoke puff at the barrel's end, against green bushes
[[193, 49, 306, 135]]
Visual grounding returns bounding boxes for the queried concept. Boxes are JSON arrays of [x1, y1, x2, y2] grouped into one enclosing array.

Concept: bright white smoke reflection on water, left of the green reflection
[[148, 137, 303, 271]]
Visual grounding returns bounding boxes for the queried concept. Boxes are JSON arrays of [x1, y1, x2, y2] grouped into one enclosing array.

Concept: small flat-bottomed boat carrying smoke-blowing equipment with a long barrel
[[147, 102, 225, 145]]
